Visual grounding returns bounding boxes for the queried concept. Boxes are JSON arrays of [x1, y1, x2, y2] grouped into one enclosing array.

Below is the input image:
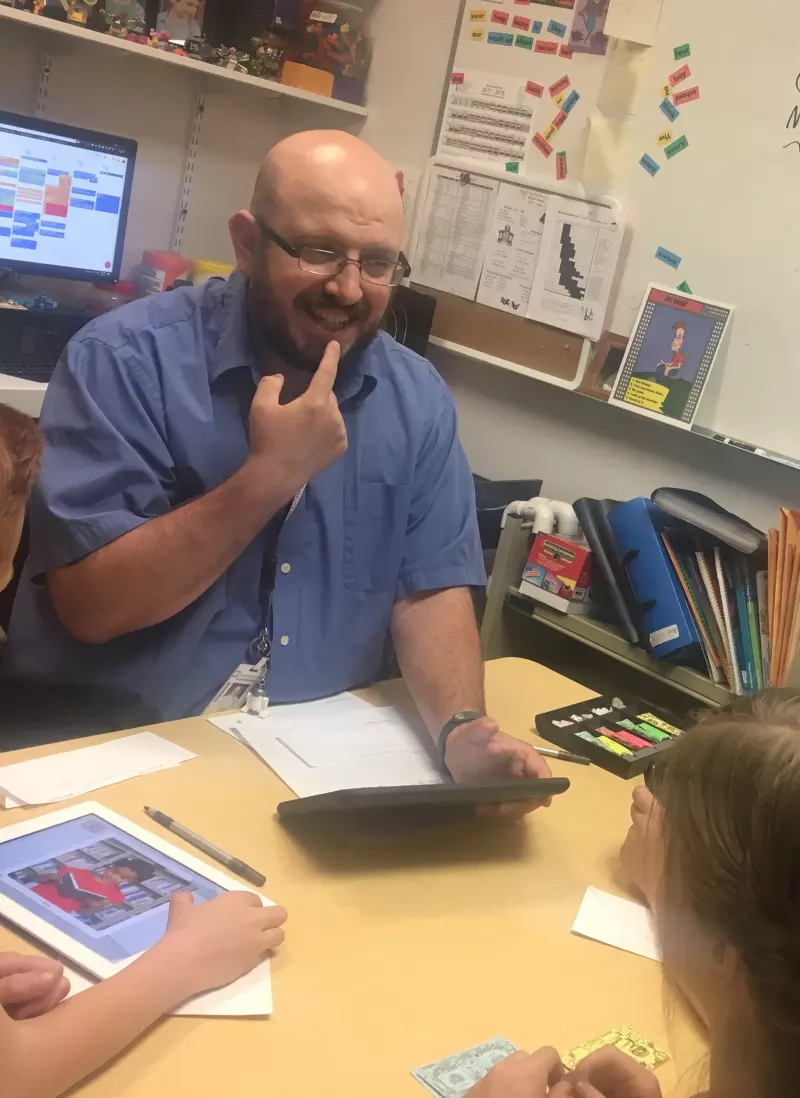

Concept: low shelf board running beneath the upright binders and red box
[[506, 587, 732, 706]]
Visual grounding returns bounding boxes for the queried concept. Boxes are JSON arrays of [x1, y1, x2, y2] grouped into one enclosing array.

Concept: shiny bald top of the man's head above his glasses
[[250, 130, 403, 239]]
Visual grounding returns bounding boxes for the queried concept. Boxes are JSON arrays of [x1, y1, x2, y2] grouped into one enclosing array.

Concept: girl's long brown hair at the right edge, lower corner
[[658, 691, 800, 1098]]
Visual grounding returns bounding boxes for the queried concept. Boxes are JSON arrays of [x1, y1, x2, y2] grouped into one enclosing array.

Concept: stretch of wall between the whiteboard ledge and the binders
[[431, 349, 800, 529]]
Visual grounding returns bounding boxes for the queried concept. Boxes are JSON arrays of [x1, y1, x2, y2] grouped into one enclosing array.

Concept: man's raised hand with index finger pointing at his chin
[[250, 343, 347, 498]]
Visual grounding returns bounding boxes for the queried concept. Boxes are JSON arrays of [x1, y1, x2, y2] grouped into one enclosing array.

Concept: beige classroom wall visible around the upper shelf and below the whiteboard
[[0, 0, 800, 526]]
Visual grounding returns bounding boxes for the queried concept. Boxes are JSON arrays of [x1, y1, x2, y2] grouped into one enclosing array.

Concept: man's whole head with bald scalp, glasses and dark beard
[[230, 130, 403, 376]]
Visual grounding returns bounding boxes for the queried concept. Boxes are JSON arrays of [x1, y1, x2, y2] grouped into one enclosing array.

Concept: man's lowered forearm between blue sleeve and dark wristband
[[392, 587, 485, 740]]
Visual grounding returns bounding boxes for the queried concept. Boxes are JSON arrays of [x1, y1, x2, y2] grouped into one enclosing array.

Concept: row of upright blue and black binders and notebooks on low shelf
[[575, 488, 768, 695]]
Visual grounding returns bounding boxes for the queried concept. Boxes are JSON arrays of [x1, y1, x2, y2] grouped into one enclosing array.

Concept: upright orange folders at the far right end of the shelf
[[768, 507, 800, 686]]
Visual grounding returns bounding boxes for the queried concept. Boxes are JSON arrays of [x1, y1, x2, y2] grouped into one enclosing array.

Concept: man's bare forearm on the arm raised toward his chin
[[47, 460, 289, 645]]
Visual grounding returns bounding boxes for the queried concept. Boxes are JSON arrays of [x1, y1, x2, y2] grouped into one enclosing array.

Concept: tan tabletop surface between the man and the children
[[0, 659, 700, 1098]]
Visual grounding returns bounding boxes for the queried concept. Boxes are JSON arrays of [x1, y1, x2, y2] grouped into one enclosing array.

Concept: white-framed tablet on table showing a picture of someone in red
[[0, 802, 272, 1016]]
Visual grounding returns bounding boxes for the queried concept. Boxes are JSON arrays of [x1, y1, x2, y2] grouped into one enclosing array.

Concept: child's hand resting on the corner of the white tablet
[[156, 892, 288, 997]]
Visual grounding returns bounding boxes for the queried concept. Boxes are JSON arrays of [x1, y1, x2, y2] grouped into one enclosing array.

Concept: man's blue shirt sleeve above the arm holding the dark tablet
[[397, 376, 486, 598]]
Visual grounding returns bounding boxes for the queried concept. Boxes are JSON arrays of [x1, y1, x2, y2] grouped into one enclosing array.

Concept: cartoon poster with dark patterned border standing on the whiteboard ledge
[[610, 285, 733, 428]]
